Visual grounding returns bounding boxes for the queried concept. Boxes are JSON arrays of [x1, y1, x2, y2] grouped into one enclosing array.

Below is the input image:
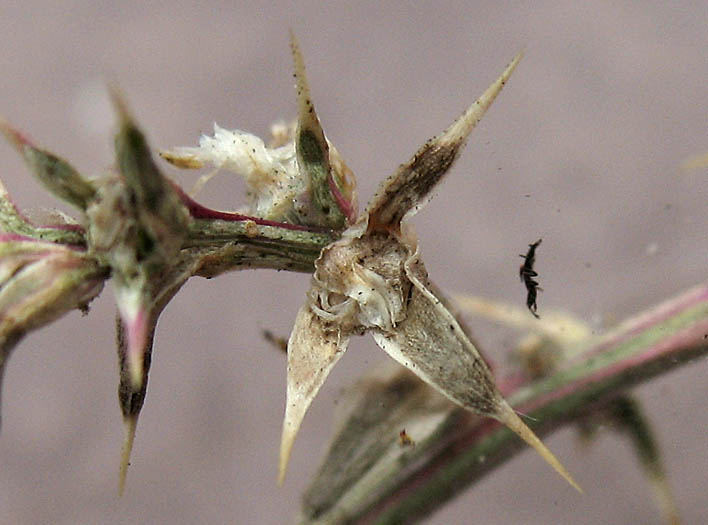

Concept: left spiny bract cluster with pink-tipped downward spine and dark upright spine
[[86, 92, 196, 492]]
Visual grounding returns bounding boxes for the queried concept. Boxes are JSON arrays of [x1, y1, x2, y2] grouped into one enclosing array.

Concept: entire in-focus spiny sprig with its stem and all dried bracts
[[0, 35, 577, 496]]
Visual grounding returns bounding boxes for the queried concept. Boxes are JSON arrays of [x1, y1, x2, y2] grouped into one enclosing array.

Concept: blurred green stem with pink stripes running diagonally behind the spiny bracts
[[354, 284, 708, 524]]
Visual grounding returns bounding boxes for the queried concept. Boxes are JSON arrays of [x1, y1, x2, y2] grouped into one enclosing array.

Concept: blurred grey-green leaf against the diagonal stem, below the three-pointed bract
[[299, 360, 457, 524]]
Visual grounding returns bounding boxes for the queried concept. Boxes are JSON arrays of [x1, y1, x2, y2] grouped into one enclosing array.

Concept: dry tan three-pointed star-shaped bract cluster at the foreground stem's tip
[[268, 37, 580, 490]]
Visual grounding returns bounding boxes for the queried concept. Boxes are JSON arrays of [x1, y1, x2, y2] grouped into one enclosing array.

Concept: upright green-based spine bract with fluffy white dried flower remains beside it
[[161, 33, 357, 230]]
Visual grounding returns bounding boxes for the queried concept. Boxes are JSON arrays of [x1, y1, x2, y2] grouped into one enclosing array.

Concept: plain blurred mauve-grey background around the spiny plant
[[0, 0, 708, 524]]
